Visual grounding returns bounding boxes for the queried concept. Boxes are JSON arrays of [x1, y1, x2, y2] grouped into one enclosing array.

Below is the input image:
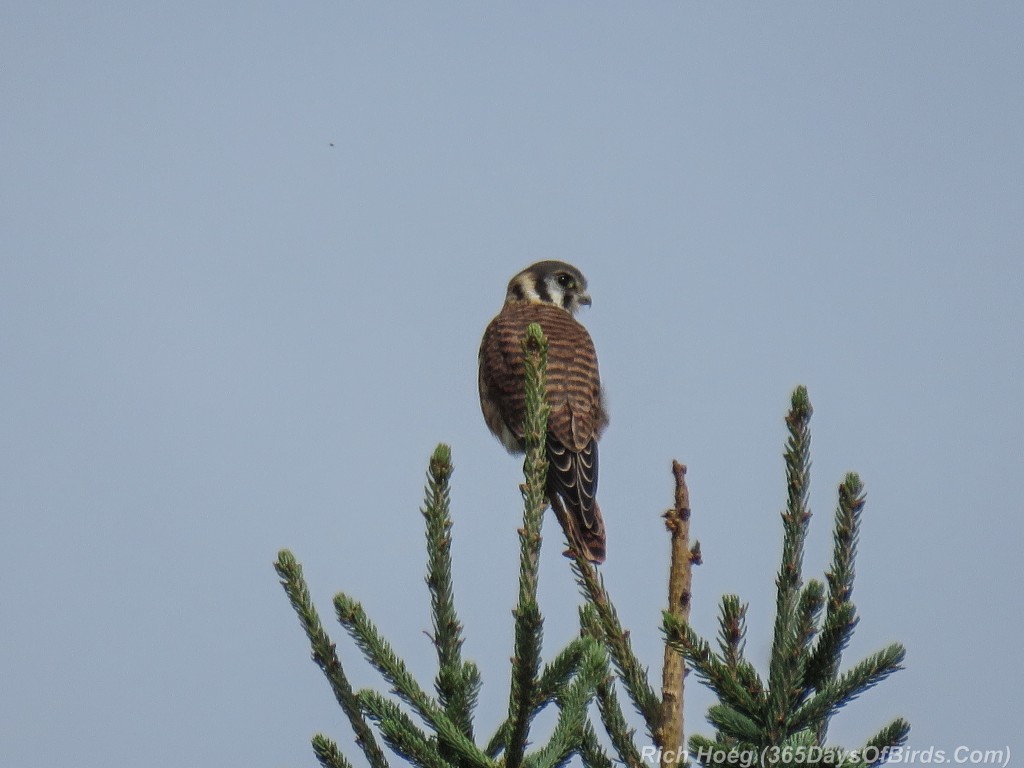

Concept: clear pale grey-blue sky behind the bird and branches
[[0, 0, 1024, 768]]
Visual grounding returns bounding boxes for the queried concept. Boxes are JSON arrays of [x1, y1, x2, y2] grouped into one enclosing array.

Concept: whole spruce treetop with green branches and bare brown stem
[[274, 325, 908, 768]]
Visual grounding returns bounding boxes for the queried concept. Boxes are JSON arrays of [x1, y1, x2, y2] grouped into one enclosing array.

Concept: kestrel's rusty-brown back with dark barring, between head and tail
[[479, 303, 607, 452]]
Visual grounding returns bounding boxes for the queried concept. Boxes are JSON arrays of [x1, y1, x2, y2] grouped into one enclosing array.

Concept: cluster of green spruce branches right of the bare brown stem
[[665, 387, 910, 766]]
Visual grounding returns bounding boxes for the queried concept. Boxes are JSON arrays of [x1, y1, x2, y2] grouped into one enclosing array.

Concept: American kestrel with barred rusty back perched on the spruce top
[[479, 261, 608, 563]]
